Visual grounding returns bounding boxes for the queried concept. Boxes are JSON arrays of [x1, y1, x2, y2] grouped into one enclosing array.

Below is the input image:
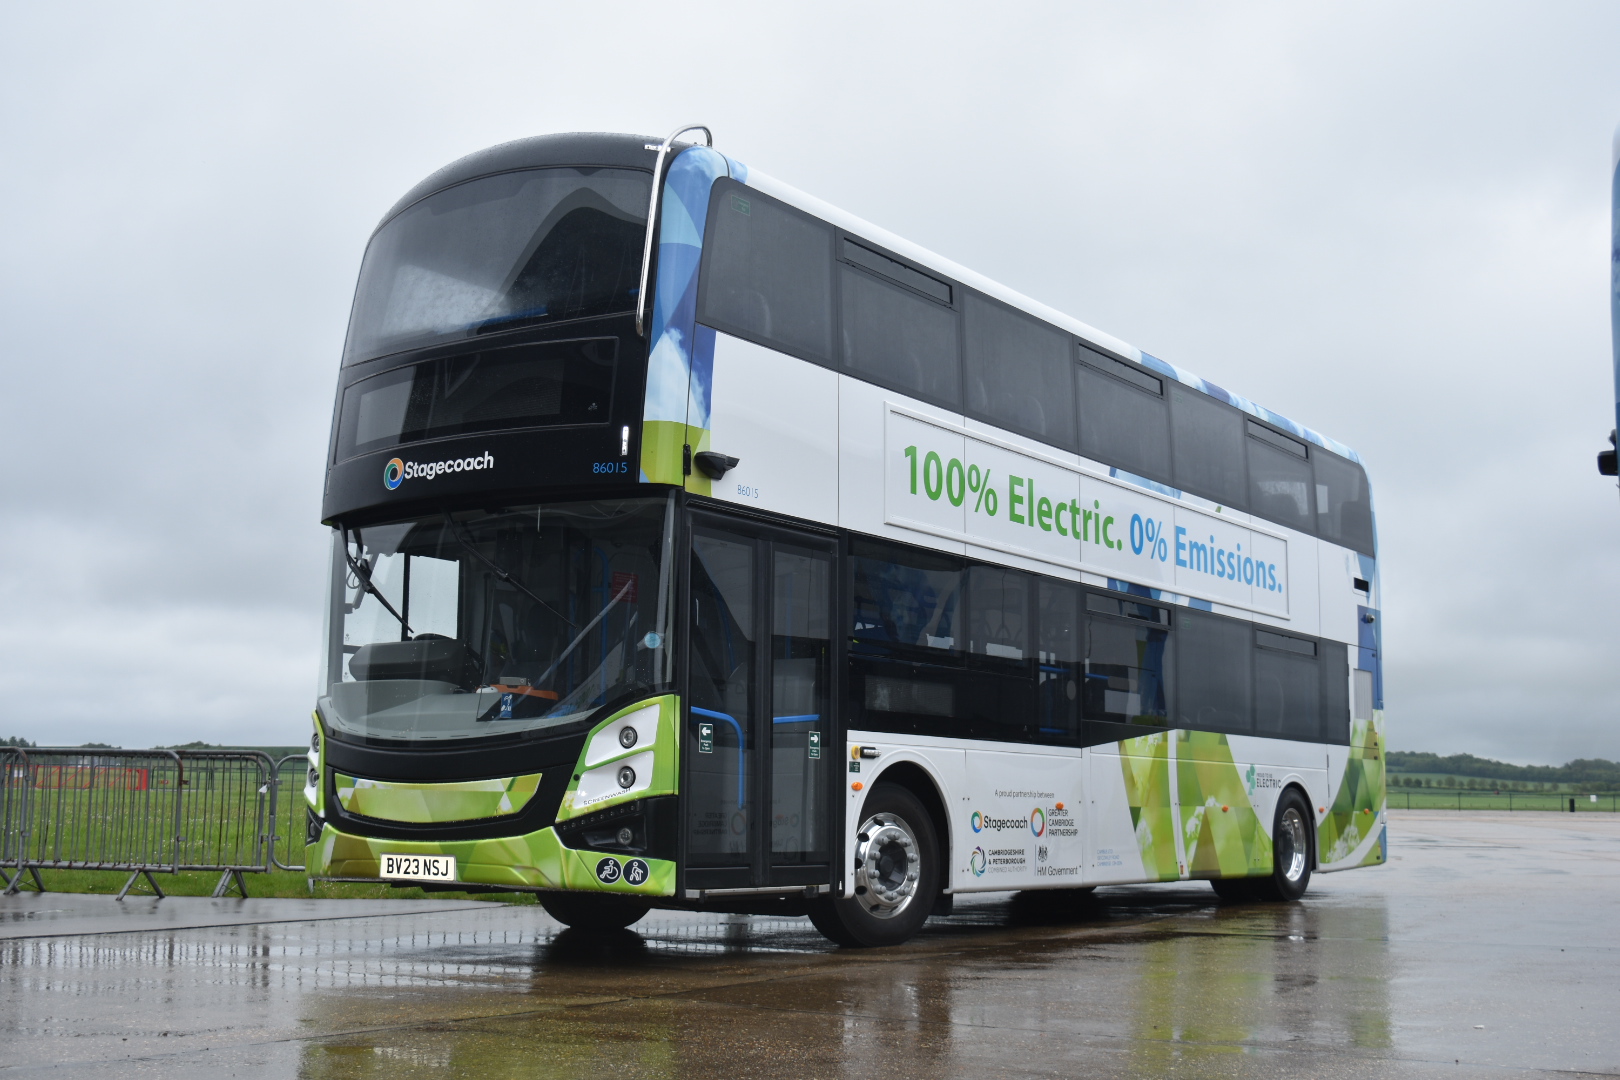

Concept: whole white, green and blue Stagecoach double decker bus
[[305, 128, 1385, 946]]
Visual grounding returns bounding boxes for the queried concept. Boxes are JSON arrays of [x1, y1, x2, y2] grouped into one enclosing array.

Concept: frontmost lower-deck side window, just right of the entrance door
[[851, 542, 964, 662]]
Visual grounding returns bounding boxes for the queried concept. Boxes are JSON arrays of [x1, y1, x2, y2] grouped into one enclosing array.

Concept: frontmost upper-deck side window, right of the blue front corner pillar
[[698, 185, 833, 363]]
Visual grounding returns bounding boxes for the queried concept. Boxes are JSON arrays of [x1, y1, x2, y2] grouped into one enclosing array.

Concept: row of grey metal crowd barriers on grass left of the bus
[[0, 746, 305, 900]]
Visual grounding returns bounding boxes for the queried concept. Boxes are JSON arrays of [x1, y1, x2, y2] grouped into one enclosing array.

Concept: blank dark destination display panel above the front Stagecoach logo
[[337, 338, 617, 460]]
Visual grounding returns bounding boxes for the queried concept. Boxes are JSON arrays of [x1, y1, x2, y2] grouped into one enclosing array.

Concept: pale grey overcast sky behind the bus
[[0, 0, 1620, 763]]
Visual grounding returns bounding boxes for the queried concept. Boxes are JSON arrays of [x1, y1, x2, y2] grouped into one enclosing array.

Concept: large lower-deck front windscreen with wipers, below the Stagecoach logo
[[321, 499, 671, 740]]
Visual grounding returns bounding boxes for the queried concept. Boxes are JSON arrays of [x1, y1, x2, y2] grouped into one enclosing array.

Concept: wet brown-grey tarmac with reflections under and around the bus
[[0, 811, 1620, 1080]]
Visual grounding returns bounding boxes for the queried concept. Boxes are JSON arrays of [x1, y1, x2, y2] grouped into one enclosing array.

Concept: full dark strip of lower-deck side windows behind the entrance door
[[846, 539, 1349, 745]]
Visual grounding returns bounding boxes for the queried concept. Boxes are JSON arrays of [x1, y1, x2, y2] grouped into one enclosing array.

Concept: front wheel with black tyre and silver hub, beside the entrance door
[[810, 784, 941, 947]]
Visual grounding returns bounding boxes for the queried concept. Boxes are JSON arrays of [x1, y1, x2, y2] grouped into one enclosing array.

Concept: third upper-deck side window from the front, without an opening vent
[[962, 293, 1074, 447]]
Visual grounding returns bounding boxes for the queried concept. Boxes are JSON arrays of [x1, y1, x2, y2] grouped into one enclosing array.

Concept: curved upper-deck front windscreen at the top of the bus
[[343, 168, 651, 363]]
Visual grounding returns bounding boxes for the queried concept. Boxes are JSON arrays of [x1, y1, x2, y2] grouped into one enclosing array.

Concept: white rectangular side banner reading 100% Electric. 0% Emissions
[[885, 405, 1288, 615]]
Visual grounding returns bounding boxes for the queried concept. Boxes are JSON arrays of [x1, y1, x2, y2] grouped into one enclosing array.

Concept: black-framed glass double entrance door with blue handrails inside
[[682, 513, 839, 895]]
